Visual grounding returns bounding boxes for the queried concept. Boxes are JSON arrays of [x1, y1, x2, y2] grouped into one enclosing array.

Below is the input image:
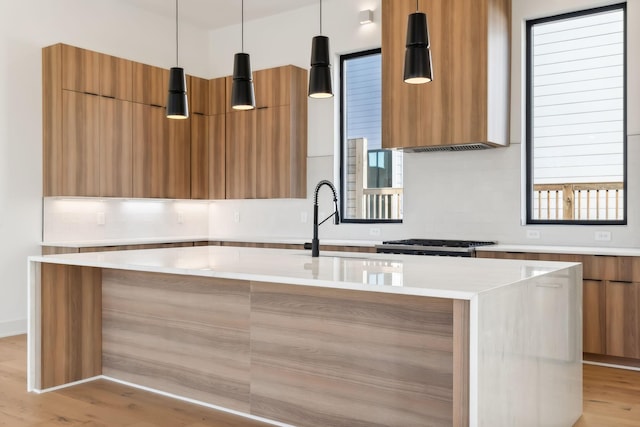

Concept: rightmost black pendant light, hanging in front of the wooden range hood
[[404, 0, 433, 84]]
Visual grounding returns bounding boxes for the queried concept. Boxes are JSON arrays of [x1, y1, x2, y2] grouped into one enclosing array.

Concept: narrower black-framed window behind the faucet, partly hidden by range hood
[[340, 49, 402, 222]]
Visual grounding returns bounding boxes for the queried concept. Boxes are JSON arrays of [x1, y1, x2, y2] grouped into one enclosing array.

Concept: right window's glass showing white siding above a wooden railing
[[526, 4, 627, 225]]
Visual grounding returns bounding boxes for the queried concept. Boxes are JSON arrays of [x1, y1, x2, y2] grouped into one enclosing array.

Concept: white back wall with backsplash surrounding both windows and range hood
[[210, 0, 640, 247]]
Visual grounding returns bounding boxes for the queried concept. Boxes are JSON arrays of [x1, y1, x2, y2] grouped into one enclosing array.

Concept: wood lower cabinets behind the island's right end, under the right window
[[476, 251, 640, 365]]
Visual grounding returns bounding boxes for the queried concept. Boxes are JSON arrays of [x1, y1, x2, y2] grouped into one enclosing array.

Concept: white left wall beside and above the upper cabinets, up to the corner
[[0, 0, 209, 336]]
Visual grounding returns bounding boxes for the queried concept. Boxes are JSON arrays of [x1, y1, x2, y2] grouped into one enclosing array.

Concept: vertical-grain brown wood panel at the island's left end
[[40, 263, 102, 389]]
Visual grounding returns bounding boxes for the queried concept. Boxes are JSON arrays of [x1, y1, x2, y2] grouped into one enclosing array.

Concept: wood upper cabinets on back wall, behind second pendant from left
[[226, 65, 307, 199]]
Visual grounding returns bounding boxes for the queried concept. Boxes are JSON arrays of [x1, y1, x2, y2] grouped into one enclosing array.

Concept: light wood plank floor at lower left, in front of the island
[[0, 335, 269, 427]]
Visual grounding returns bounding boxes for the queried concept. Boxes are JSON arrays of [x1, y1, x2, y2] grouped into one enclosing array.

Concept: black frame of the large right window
[[525, 2, 629, 226]]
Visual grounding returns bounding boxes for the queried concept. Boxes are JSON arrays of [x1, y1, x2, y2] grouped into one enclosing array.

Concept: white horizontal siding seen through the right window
[[529, 9, 625, 184]]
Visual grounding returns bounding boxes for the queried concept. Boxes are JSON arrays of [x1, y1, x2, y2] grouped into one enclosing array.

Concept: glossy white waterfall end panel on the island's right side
[[477, 265, 582, 427]]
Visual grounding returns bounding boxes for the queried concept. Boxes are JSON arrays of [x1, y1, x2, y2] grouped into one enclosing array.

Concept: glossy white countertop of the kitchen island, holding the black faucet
[[29, 246, 577, 299]]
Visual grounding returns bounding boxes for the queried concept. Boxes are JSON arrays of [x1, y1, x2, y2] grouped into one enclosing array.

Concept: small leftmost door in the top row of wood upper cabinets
[[59, 44, 100, 95]]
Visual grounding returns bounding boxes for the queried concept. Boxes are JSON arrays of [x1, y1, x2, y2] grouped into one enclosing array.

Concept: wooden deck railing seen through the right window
[[533, 182, 624, 220]]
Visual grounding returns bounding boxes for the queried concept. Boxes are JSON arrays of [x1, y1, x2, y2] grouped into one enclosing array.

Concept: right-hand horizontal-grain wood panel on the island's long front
[[251, 282, 468, 427]]
